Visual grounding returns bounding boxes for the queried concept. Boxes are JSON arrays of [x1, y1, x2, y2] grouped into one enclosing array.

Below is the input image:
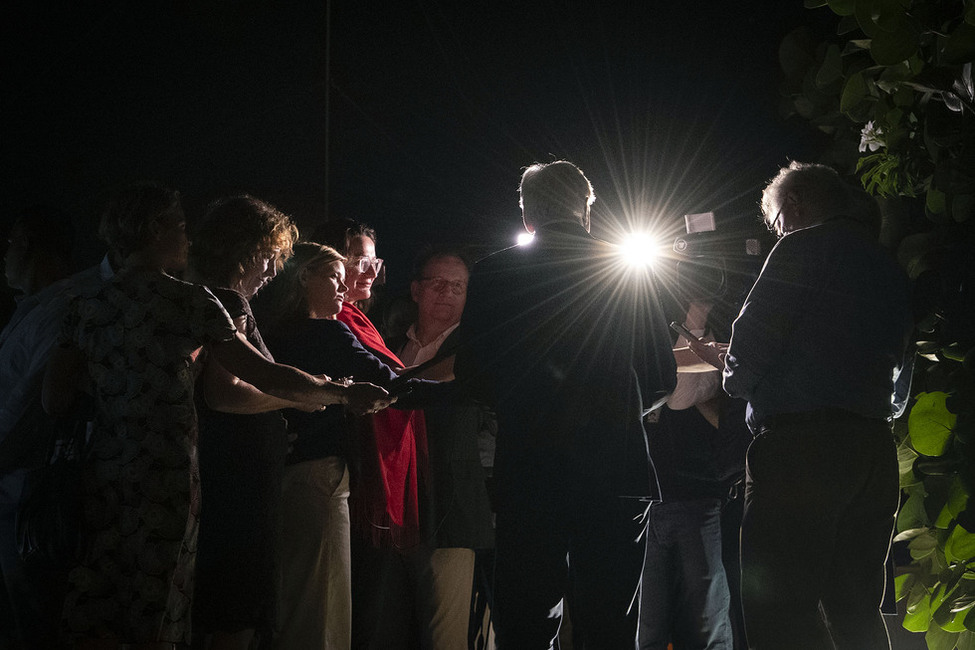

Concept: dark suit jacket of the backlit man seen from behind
[[455, 221, 676, 509]]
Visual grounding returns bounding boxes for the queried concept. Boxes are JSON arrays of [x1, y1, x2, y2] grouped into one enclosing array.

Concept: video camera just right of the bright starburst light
[[674, 212, 771, 301]]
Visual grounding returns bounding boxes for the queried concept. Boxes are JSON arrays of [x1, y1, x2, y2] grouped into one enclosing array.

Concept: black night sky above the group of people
[[0, 0, 835, 292]]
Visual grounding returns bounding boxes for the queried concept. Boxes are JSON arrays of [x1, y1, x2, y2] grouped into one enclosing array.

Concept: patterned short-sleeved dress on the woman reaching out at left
[[62, 271, 236, 643]]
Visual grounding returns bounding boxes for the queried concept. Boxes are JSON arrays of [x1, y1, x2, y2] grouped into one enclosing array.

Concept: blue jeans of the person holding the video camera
[[639, 499, 734, 650]]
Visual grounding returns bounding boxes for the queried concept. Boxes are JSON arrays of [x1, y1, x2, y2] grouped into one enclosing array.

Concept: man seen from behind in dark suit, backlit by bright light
[[455, 161, 676, 650]]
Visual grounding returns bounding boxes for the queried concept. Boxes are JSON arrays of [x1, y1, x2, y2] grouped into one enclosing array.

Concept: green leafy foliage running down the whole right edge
[[779, 0, 975, 650]]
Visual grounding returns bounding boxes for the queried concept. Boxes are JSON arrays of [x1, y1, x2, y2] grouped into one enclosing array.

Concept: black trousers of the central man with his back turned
[[494, 486, 646, 650]]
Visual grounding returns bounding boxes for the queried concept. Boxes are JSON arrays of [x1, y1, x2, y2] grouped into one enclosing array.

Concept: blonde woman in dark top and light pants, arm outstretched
[[262, 243, 442, 650]]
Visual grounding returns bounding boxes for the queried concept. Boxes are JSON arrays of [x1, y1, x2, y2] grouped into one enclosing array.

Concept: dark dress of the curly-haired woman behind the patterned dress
[[193, 289, 288, 633]]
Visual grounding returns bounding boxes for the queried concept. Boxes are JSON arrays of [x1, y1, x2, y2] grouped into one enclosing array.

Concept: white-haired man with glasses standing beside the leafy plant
[[692, 162, 912, 650]]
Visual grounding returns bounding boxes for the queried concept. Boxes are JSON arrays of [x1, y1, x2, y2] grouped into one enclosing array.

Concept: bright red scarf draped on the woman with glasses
[[337, 303, 427, 548]]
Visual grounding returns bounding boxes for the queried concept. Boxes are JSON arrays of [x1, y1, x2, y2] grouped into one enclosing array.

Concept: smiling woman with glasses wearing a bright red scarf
[[315, 220, 427, 648]]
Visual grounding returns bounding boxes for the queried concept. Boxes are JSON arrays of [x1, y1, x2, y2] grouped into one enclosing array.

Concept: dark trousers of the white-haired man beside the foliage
[[741, 412, 899, 650]]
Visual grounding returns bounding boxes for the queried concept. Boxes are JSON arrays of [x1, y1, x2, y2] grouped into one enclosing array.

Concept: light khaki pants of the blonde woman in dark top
[[274, 456, 352, 650]]
